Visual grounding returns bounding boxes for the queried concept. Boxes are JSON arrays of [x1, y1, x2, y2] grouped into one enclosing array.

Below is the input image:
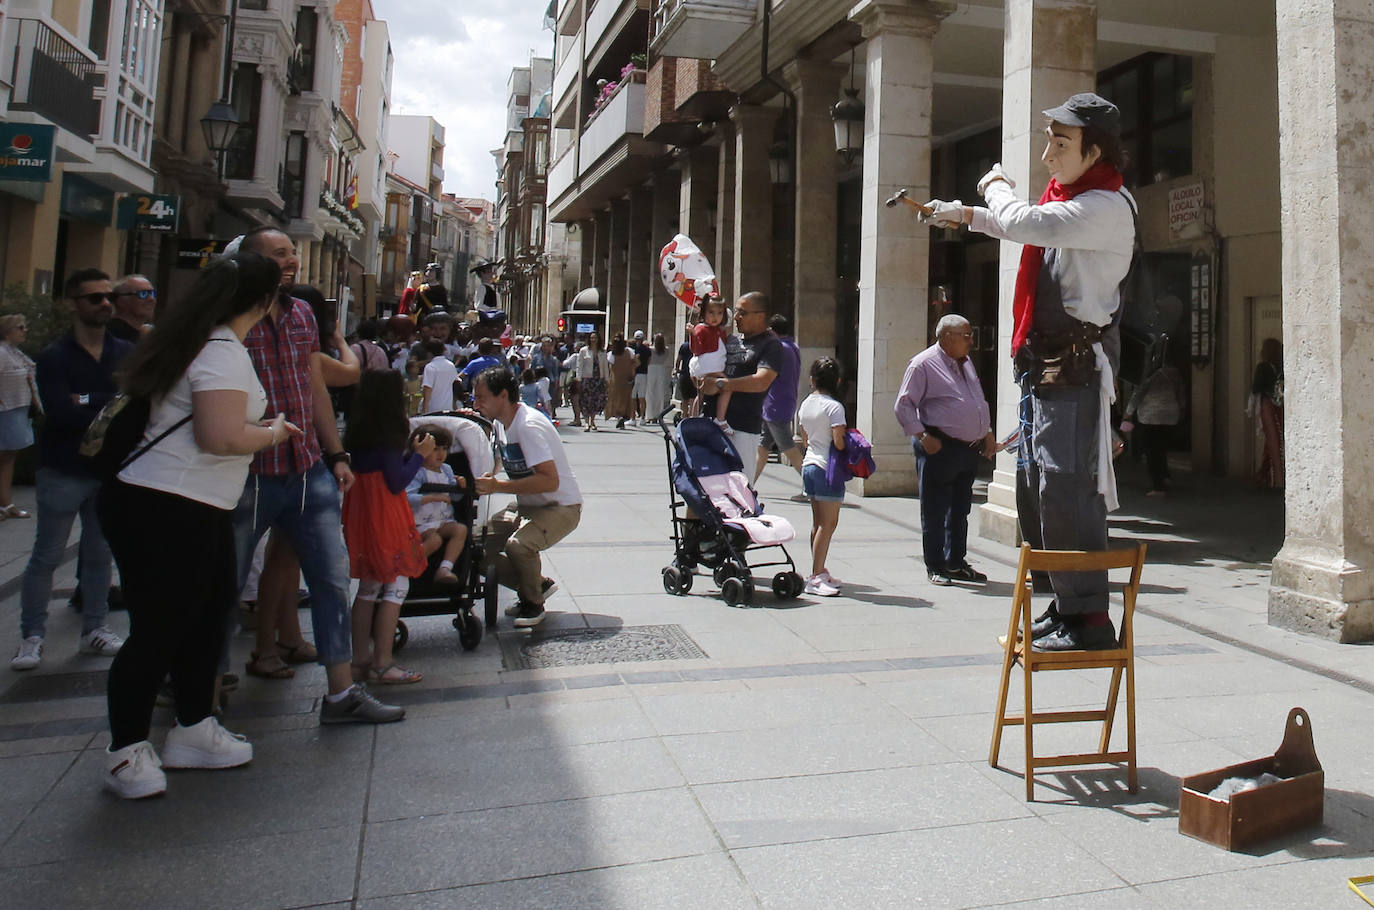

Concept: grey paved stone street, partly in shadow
[[0, 426, 1374, 910]]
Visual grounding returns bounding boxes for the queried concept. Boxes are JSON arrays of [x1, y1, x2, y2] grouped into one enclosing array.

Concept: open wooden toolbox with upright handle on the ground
[[1179, 708, 1326, 851]]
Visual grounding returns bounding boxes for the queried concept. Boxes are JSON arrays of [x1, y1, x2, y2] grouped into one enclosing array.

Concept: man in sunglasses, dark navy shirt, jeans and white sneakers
[[10, 268, 133, 669]]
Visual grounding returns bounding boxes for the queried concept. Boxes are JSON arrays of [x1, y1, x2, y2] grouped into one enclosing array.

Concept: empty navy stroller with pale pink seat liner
[[657, 408, 804, 606]]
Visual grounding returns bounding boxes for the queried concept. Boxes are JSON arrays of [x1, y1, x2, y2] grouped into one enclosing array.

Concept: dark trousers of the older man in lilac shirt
[[912, 441, 978, 572]]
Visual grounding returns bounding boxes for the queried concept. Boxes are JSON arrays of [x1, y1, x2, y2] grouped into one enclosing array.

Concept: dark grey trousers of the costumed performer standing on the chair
[[1017, 378, 1107, 614]]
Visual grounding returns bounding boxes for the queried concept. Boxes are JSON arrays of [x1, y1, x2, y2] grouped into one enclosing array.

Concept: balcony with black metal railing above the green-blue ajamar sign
[[10, 19, 104, 139]]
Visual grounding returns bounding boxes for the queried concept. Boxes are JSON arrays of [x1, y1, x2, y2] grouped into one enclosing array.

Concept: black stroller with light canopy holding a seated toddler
[[393, 411, 497, 650]]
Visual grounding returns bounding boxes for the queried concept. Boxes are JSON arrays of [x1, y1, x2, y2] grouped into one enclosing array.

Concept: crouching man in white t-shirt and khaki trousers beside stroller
[[473, 367, 583, 628]]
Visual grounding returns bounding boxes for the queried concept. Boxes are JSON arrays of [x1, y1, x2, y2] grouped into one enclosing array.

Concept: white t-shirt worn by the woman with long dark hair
[[120, 326, 267, 509]]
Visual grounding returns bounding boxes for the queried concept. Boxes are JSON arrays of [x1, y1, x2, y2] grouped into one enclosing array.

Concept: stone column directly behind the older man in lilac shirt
[[846, 0, 951, 495]]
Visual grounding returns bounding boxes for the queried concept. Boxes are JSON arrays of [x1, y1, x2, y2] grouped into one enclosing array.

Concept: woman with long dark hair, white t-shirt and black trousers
[[96, 253, 301, 799]]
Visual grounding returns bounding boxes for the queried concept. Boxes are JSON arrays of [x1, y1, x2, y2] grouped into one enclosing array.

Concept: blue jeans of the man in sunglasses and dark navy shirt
[[19, 467, 111, 638]]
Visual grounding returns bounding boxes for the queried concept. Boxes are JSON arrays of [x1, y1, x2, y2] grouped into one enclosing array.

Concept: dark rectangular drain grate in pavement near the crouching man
[[497, 625, 706, 669]]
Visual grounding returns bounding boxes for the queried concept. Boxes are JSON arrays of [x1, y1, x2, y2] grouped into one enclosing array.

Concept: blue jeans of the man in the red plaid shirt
[[234, 462, 353, 667]]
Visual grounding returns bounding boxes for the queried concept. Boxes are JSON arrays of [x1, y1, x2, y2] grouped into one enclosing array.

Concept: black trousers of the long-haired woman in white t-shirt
[[96, 481, 238, 749]]
